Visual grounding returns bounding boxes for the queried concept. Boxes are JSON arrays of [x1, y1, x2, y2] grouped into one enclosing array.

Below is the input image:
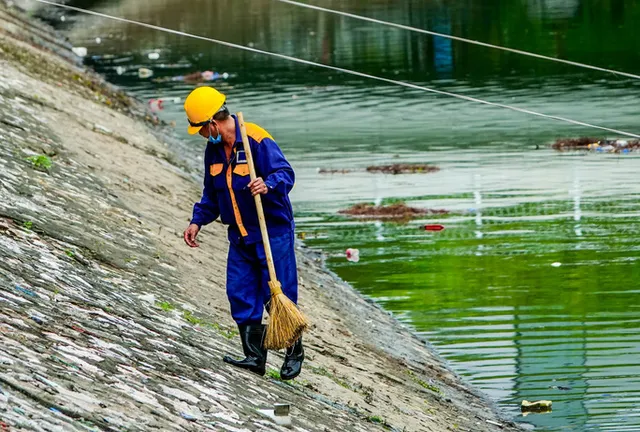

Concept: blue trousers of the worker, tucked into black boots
[[227, 230, 298, 325]]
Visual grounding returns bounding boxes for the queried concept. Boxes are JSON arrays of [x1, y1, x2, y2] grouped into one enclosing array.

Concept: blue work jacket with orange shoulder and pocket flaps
[[191, 116, 295, 244]]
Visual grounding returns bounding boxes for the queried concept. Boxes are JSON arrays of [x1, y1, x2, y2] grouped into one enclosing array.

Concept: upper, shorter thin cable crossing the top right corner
[[275, 0, 640, 79]]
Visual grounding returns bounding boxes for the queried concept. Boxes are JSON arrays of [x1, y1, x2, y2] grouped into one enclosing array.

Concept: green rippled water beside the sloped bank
[[53, 0, 640, 431]]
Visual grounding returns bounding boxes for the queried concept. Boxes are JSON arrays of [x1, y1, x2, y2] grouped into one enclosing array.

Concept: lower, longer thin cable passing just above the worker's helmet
[[35, 0, 640, 138]]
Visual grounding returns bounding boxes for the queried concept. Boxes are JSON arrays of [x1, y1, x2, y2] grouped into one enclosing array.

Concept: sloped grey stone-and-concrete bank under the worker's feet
[[0, 3, 519, 431]]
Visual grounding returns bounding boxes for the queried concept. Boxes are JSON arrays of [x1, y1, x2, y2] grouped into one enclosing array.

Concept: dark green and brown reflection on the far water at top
[[66, 0, 640, 82]]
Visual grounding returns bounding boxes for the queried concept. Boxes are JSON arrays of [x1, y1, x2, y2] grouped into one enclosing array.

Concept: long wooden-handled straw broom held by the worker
[[237, 112, 309, 350]]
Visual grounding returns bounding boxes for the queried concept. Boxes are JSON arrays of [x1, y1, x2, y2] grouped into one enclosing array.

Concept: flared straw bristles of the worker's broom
[[264, 280, 309, 350]]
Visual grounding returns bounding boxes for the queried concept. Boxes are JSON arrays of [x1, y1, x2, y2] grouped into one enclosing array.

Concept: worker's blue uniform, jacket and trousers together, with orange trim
[[191, 116, 298, 325]]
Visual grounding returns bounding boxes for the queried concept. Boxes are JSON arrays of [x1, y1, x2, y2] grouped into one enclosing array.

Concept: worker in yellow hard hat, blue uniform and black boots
[[184, 87, 304, 380]]
